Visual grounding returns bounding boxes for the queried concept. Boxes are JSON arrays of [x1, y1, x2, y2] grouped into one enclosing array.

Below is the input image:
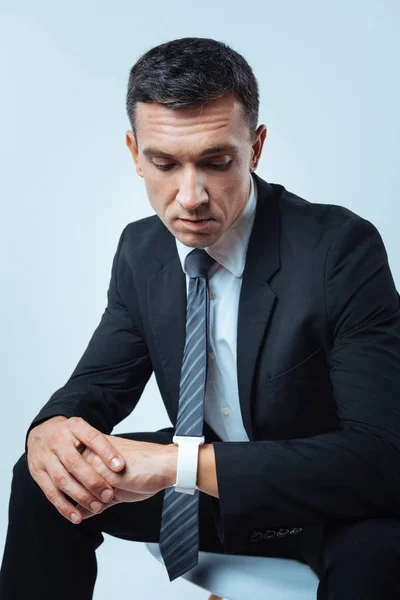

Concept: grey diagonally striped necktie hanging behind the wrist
[[160, 248, 215, 581]]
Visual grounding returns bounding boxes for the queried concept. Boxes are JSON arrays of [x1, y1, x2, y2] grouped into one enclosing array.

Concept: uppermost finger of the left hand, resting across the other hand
[[68, 417, 125, 471]]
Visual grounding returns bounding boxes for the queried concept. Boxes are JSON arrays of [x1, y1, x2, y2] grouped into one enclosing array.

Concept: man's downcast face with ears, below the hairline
[[126, 96, 266, 248]]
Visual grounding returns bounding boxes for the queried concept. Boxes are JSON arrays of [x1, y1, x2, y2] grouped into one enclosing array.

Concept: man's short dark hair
[[126, 37, 259, 138]]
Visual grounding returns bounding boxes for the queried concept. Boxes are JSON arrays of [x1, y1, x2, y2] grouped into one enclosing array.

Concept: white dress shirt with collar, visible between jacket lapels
[[175, 175, 257, 454]]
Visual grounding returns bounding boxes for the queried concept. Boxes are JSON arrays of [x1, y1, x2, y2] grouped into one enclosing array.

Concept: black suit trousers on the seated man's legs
[[0, 428, 400, 600]]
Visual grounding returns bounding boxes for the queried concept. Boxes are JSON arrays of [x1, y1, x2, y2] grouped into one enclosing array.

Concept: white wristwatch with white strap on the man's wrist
[[172, 435, 204, 494]]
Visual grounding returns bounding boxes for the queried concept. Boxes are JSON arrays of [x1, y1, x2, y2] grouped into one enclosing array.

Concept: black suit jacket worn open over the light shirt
[[27, 174, 400, 554]]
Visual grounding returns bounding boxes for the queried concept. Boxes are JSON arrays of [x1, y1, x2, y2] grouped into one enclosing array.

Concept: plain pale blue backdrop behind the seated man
[[0, 0, 400, 600]]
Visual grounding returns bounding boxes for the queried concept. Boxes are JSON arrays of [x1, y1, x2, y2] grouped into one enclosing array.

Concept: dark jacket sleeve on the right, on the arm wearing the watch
[[214, 215, 400, 553]]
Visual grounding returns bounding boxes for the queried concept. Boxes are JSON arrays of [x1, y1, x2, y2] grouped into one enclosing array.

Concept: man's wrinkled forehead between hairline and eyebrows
[[136, 96, 248, 154]]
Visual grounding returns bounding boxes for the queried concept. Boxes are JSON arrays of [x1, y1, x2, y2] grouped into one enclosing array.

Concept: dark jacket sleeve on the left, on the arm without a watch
[[25, 225, 153, 453]]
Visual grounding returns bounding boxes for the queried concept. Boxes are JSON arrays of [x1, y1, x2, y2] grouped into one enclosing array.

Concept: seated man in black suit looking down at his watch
[[0, 38, 400, 600]]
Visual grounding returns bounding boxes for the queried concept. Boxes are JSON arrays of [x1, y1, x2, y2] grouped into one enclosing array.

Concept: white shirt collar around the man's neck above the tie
[[175, 174, 257, 278]]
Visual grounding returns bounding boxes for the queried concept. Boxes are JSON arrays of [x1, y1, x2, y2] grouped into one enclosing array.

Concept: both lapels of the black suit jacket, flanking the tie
[[147, 173, 280, 440]]
